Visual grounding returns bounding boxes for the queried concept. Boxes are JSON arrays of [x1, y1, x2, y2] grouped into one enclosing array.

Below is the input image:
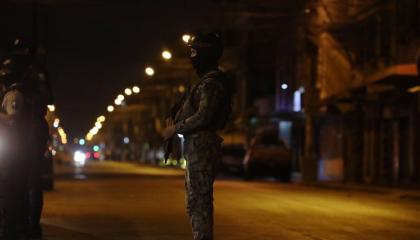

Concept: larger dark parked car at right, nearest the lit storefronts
[[243, 135, 293, 182]]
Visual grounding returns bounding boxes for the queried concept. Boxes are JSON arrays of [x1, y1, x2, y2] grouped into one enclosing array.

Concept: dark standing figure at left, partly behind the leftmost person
[[13, 38, 53, 239]]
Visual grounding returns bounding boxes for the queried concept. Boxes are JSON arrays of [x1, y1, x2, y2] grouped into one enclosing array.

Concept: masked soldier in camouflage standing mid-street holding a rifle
[[163, 33, 232, 240]]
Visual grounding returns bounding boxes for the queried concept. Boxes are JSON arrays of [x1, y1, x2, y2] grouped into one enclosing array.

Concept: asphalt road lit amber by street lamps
[[42, 162, 420, 240]]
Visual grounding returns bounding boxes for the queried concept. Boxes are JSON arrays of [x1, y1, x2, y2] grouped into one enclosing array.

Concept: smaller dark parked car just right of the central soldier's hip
[[220, 144, 246, 173]]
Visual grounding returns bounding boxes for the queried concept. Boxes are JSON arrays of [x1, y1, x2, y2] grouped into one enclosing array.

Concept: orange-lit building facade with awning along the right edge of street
[[297, 0, 420, 185]]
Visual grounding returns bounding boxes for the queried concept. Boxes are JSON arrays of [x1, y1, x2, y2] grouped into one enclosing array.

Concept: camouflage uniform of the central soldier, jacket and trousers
[[175, 70, 227, 240]]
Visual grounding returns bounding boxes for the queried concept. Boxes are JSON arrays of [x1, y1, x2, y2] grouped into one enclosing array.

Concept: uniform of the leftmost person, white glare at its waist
[[0, 85, 30, 240]]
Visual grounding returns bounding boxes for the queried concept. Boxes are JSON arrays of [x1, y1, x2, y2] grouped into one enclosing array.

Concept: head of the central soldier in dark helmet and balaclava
[[189, 33, 223, 77]]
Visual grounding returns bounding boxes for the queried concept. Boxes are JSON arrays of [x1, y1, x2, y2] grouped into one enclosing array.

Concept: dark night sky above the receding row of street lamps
[[0, 0, 221, 137]]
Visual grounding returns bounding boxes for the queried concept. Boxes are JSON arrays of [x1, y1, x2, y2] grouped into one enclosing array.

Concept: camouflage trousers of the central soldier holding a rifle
[[185, 133, 222, 240]]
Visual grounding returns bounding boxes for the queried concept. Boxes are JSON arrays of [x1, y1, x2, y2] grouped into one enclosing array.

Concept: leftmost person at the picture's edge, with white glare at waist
[[0, 44, 32, 240]]
